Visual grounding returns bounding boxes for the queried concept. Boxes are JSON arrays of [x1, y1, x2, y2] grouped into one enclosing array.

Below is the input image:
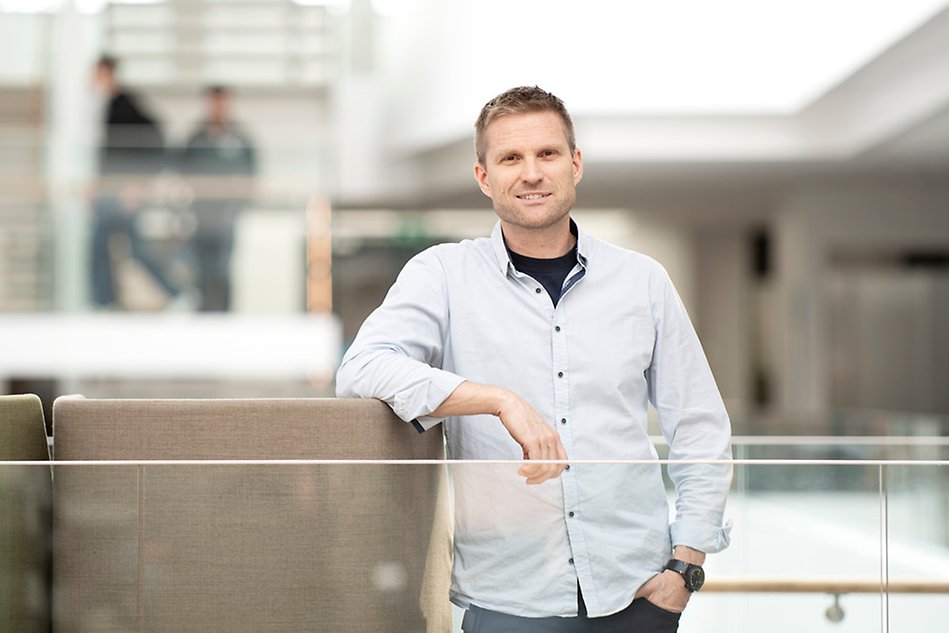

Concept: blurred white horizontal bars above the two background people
[[104, 0, 339, 92]]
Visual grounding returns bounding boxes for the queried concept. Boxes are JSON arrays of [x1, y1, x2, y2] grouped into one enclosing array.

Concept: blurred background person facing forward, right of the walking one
[[178, 86, 257, 312]]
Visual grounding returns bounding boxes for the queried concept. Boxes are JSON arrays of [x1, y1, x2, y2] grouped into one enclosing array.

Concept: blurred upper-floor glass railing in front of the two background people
[[0, 128, 332, 313]]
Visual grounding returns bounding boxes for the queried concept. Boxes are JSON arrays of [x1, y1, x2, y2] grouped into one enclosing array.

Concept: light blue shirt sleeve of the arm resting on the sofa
[[336, 247, 464, 429]]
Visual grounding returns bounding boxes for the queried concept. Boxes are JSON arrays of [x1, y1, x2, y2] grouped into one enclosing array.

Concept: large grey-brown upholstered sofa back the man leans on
[[52, 398, 451, 633]]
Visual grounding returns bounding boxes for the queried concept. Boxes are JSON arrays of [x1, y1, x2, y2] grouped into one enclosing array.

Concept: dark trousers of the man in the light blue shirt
[[461, 595, 681, 633]]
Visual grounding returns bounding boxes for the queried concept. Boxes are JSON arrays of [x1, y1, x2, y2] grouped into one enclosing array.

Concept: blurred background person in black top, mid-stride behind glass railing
[[91, 55, 188, 309]]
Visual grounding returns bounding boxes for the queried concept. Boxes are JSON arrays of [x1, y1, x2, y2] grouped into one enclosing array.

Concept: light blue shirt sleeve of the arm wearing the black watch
[[647, 267, 732, 553]]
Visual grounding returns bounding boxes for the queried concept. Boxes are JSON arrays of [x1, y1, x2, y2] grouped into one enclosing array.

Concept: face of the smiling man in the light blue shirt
[[475, 111, 583, 236]]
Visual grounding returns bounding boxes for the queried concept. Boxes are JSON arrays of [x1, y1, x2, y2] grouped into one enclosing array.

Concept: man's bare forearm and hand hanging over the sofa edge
[[431, 381, 567, 485]]
